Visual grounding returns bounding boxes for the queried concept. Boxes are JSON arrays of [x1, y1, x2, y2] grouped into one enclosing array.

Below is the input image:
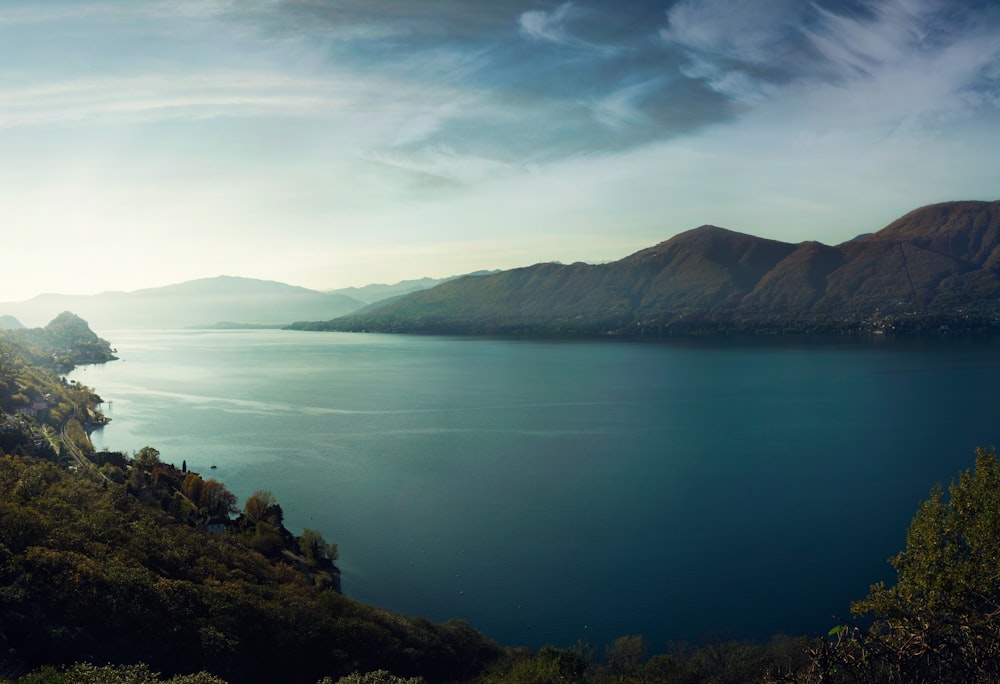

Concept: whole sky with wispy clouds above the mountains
[[0, 0, 1000, 301]]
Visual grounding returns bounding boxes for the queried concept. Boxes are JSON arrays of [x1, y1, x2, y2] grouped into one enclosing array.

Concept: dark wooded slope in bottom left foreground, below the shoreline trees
[[0, 455, 499, 684]]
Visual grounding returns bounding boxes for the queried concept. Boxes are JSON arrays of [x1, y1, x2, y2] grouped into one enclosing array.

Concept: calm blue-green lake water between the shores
[[72, 330, 1000, 650]]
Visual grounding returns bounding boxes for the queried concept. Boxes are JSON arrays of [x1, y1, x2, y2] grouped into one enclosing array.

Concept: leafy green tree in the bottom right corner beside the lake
[[814, 449, 1000, 682]]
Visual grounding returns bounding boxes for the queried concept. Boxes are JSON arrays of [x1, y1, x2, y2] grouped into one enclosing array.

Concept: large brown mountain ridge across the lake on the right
[[294, 202, 1000, 336]]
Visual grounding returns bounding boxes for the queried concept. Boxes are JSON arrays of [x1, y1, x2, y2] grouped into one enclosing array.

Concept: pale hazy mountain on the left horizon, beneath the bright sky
[[0, 276, 363, 330]]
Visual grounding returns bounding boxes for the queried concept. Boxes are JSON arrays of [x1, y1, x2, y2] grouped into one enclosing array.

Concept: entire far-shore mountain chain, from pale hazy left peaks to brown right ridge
[[9, 201, 1000, 337]]
